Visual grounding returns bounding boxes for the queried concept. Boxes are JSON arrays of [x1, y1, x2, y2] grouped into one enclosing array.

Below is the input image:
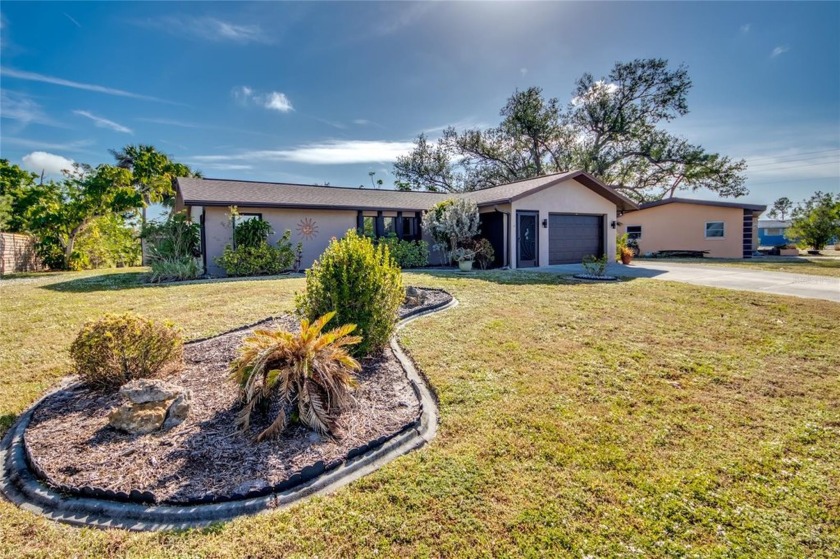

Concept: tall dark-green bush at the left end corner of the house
[[142, 212, 204, 283]]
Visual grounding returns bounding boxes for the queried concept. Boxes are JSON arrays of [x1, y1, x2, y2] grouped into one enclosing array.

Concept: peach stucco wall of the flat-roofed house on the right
[[619, 203, 744, 258]]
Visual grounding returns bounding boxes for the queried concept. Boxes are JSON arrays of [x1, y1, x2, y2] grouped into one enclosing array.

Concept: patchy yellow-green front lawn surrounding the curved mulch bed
[[0, 271, 840, 558]]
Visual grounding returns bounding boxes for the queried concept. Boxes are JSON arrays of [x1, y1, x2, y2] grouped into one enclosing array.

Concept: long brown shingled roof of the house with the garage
[[175, 171, 637, 211]]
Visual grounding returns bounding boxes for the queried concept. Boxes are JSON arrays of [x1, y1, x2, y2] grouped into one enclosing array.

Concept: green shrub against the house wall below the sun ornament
[[216, 230, 302, 277]]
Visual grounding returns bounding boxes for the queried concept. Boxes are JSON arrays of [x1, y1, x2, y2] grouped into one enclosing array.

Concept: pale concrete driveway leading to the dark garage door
[[528, 261, 840, 303]]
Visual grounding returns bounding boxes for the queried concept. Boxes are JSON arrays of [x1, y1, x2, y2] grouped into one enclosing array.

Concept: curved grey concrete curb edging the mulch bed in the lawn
[[0, 290, 458, 531]]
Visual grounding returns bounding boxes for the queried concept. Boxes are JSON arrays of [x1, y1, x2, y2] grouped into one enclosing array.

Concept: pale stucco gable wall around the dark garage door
[[510, 180, 616, 267]]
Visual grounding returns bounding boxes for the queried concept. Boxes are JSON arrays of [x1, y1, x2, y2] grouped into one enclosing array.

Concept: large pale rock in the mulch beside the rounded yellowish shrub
[[108, 379, 191, 435]]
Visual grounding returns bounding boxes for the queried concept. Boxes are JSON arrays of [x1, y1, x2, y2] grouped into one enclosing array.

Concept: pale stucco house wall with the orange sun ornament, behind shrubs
[[204, 206, 357, 276]]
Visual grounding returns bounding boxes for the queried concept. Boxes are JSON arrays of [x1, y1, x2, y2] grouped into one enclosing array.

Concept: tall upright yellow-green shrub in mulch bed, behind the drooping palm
[[296, 230, 405, 356]]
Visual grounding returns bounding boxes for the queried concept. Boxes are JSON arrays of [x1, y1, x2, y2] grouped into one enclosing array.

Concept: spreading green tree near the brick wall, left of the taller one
[[21, 164, 142, 269]]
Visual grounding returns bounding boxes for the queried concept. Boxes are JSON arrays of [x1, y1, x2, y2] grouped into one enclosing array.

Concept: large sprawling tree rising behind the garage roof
[[395, 59, 748, 201]]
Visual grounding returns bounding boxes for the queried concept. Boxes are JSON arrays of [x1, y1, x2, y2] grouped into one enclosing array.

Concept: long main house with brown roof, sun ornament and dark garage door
[[176, 171, 637, 275]]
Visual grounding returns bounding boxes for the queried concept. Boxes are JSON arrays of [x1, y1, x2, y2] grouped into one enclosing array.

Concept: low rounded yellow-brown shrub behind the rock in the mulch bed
[[70, 313, 184, 389]]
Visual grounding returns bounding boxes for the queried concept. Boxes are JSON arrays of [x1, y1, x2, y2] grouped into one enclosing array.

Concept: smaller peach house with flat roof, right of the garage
[[619, 198, 766, 258]]
